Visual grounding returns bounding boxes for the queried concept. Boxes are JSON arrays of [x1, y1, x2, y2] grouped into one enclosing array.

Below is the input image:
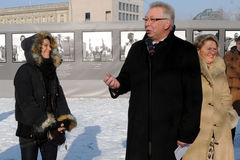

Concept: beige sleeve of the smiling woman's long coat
[[221, 74, 238, 128]]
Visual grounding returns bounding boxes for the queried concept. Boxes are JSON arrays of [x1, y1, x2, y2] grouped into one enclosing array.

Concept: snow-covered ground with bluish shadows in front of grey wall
[[0, 98, 240, 160]]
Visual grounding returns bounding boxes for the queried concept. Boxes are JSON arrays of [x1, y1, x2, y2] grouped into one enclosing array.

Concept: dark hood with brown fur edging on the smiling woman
[[21, 31, 62, 67]]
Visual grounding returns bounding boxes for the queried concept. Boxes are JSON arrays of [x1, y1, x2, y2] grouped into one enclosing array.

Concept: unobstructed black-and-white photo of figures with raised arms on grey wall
[[83, 32, 113, 62]]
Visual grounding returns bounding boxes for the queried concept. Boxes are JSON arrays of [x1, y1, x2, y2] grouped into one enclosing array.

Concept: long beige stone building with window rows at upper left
[[0, 2, 69, 24]]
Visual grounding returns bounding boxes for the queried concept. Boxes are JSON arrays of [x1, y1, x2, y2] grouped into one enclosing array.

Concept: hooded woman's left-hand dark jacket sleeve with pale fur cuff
[[14, 66, 55, 132]]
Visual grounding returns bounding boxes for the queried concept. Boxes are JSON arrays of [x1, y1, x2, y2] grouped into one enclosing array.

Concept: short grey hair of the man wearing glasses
[[150, 1, 175, 30]]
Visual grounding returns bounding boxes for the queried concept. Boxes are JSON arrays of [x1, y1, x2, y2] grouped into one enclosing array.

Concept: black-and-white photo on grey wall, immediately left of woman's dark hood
[[12, 33, 35, 62]]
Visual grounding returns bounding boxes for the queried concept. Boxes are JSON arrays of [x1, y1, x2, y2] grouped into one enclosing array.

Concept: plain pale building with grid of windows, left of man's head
[[69, 0, 143, 22]]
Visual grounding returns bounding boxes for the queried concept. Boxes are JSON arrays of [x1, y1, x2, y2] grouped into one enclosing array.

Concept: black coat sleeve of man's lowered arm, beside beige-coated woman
[[178, 46, 202, 143]]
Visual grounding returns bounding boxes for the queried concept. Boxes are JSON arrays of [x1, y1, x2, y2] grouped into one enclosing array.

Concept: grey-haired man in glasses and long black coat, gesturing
[[104, 2, 202, 160]]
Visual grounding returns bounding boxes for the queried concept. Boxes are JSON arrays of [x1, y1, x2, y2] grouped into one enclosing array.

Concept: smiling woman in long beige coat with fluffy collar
[[183, 35, 238, 160]]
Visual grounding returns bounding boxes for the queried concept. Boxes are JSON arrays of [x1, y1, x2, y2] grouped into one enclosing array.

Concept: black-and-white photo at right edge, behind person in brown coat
[[224, 31, 240, 53]]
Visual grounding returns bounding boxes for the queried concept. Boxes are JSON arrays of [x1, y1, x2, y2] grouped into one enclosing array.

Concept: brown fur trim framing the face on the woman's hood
[[32, 31, 62, 67]]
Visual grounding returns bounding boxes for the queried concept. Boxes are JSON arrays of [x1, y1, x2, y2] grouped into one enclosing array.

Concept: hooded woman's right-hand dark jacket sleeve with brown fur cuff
[[56, 80, 77, 131]]
